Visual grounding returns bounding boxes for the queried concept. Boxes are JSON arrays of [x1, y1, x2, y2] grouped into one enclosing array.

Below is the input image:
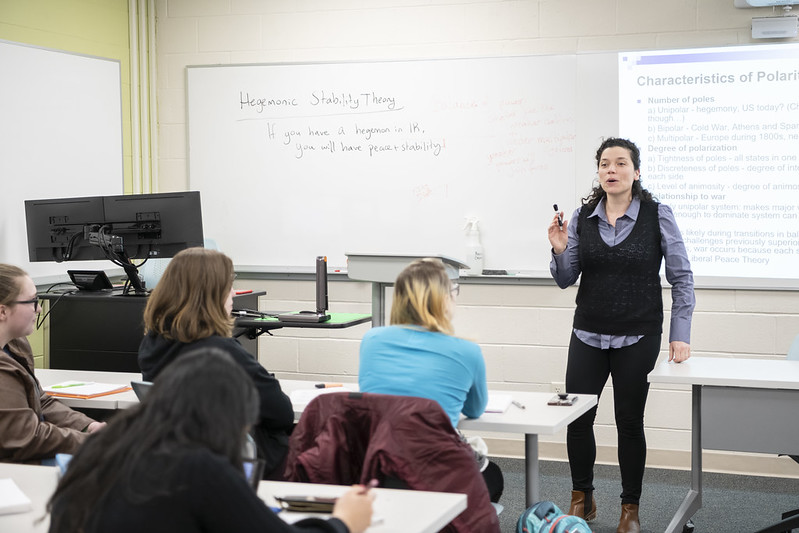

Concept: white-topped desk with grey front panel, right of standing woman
[[649, 357, 799, 533]]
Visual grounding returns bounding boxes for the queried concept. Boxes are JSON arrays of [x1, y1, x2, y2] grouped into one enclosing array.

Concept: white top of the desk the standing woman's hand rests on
[[649, 357, 799, 390]]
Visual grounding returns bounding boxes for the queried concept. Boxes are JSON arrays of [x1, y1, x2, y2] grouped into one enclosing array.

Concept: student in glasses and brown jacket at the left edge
[[0, 264, 105, 463]]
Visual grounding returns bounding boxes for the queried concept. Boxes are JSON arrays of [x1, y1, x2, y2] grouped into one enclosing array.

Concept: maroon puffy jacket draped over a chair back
[[285, 392, 499, 533]]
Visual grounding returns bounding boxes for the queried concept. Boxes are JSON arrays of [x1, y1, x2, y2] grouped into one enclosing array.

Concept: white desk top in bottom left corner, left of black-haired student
[[0, 463, 58, 533]]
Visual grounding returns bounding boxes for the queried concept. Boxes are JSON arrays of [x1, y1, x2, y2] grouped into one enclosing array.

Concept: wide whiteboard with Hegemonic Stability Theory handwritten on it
[[187, 54, 618, 274]]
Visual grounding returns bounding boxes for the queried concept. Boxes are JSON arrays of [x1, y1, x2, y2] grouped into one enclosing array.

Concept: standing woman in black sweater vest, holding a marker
[[548, 138, 695, 533]]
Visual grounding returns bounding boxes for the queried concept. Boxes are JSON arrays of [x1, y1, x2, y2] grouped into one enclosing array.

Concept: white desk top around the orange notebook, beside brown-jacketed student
[[35, 368, 141, 409]]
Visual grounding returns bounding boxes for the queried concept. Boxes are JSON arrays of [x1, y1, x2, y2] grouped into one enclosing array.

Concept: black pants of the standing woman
[[566, 333, 661, 504]]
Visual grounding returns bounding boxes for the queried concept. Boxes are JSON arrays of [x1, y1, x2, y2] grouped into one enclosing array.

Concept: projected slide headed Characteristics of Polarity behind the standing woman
[[619, 44, 799, 287]]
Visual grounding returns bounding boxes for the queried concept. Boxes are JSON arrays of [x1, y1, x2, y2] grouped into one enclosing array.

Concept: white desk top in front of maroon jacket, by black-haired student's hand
[[258, 481, 466, 533]]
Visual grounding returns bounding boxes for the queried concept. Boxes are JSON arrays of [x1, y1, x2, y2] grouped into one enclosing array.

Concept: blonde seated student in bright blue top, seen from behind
[[358, 258, 504, 502]]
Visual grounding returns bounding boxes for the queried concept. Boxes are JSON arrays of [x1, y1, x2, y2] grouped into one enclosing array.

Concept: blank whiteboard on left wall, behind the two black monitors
[[0, 41, 123, 282]]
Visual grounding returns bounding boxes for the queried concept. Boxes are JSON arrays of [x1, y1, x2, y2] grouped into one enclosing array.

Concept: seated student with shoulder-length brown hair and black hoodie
[[139, 248, 294, 479]]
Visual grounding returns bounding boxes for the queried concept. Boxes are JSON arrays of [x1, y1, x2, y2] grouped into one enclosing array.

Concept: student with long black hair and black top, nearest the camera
[[48, 347, 374, 533]]
